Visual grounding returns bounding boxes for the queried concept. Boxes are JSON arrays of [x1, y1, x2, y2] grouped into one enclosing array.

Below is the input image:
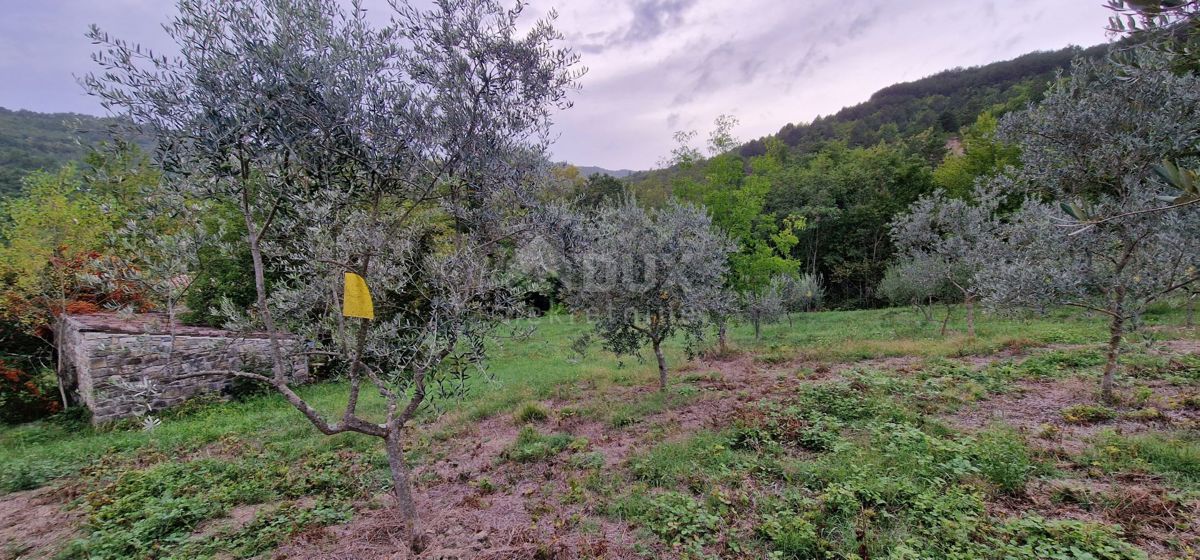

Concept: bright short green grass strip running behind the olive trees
[[0, 304, 1113, 489]]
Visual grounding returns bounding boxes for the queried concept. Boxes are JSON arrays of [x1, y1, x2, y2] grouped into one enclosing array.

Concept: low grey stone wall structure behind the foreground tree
[[59, 313, 308, 423]]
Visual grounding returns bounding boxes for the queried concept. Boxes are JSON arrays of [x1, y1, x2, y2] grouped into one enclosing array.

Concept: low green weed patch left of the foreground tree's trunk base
[[61, 452, 379, 560]]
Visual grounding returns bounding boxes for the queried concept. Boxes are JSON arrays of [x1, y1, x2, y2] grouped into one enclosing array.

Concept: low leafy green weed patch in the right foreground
[[606, 363, 1145, 560]]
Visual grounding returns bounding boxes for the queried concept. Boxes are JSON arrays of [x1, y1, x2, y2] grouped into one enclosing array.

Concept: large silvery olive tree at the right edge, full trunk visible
[[977, 50, 1200, 399]]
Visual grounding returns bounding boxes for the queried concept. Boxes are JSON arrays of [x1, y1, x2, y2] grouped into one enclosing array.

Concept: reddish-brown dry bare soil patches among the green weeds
[[0, 342, 1200, 560]]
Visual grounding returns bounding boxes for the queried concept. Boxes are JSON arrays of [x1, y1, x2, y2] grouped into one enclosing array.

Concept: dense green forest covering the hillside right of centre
[[628, 46, 1108, 308]]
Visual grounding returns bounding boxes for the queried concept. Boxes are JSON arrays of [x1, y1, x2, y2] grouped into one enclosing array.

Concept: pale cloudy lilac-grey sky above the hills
[[0, 0, 1109, 169]]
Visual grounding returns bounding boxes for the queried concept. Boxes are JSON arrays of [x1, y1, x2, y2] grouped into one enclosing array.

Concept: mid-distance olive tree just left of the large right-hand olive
[[892, 187, 1003, 338]]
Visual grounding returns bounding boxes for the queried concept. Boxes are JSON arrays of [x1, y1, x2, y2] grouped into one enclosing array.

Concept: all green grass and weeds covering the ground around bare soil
[[0, 307, 1200, 558]]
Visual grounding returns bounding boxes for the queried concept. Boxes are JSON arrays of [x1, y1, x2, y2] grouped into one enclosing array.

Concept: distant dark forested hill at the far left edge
[[0, 107, 133, 199]]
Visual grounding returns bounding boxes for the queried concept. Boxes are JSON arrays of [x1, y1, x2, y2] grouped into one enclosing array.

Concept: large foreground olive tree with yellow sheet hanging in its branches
[[83, 0, 580, 547]]
